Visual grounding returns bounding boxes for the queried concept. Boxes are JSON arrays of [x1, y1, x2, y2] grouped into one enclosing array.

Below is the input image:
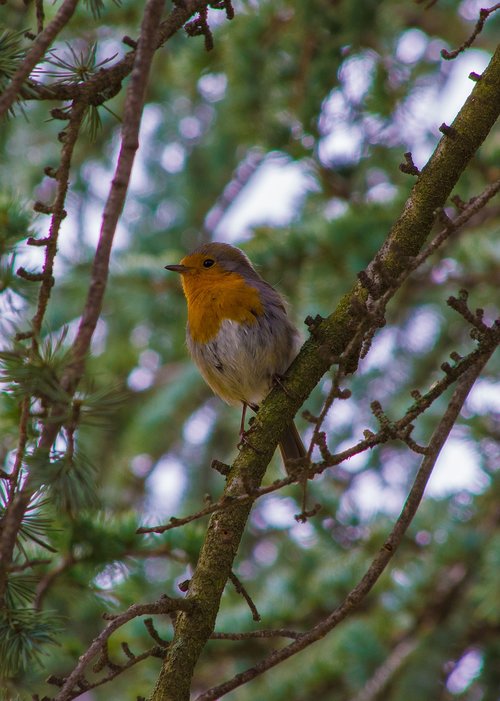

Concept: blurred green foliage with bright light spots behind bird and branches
[[0, 0, 500, 701]]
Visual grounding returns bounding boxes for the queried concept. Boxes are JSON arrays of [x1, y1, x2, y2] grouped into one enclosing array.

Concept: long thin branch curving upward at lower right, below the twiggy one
[[196, 349, 494, 701]]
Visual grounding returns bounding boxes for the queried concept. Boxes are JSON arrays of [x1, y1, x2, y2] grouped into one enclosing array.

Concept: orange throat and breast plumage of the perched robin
[[182, 271, 264, 343]]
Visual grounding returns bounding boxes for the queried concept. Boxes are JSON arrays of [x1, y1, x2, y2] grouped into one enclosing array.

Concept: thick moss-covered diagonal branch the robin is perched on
[[152, 47, 500, 701]]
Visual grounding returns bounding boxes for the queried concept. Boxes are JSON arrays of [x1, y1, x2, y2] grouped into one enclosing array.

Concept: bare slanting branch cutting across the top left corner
[[0, 0, 78, 117]]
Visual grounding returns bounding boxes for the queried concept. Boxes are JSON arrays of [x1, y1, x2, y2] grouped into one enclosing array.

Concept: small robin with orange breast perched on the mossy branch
[[165, 243, 306, 465]]
